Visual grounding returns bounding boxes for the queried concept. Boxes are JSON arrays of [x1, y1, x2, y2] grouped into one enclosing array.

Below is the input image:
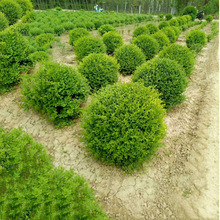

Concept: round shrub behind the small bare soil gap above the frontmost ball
[[115, 44, 145, 75]]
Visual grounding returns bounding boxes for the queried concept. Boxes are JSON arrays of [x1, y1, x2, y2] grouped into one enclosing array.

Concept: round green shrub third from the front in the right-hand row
[[159, 44, 195, 76]]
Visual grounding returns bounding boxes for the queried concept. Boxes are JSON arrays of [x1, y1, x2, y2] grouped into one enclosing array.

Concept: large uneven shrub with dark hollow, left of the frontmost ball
[[21, 62, 89, 127]]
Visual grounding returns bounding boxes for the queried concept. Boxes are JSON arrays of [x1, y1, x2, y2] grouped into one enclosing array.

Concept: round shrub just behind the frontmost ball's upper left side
[[79, 54, 119, 92]]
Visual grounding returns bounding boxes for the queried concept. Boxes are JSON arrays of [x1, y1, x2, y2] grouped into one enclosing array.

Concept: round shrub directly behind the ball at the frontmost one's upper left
[[74, 36, 106, 61]]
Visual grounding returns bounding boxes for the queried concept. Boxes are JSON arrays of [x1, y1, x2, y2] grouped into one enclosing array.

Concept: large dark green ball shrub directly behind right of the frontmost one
[[132, 58, 188, 110]]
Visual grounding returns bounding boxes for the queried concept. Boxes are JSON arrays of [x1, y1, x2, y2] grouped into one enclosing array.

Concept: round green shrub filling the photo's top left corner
[[0, 0, 22, 25]]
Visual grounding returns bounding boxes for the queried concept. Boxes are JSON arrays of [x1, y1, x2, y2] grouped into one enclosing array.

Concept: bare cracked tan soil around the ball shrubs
[[0, 21, 219, 220]]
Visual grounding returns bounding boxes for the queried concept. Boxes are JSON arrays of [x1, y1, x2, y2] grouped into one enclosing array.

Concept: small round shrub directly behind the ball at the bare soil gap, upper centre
[[102, 31, 124, 54]]
